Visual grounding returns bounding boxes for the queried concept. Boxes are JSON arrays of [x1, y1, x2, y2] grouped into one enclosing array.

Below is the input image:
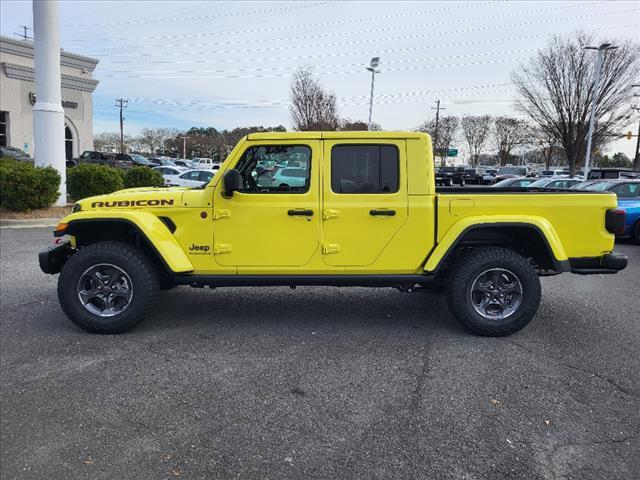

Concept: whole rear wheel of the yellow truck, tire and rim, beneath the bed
[[447, 248, 541, 337]]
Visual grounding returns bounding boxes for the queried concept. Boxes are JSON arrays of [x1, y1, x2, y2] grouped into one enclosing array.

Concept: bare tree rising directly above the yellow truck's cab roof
[[289, 68, 339, 131]]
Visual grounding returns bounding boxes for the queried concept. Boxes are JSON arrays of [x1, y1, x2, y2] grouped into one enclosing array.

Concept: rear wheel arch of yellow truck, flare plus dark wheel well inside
[[424, 218, 570, 274]]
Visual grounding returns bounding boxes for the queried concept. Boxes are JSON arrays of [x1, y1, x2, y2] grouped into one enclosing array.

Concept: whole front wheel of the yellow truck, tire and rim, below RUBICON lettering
[[58, 242, 158, 333]]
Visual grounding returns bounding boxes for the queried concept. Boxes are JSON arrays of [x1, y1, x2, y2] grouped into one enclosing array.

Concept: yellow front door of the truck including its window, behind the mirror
[[213, 140, 322, 270]]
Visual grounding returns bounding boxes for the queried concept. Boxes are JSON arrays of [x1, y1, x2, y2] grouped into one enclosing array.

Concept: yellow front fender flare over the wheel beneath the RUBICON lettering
[[60, 210, 193, 273]]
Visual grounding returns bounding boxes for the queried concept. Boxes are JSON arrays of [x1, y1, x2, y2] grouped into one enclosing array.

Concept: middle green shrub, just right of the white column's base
[[67, 163, 124, 200]]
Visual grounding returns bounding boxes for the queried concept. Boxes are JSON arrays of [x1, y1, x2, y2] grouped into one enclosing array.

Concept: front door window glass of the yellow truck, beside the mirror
[[235, 145, 311, 193]]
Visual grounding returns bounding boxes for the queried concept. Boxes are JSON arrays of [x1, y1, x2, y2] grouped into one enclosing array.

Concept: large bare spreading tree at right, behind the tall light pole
[[512, 32, 640, 175]]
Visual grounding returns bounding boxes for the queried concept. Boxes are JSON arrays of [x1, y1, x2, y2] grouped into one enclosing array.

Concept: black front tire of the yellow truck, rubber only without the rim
[[58, 242, 159, 333]]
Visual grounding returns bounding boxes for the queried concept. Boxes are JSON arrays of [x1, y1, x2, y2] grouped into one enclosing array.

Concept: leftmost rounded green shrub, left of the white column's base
[[0, 157, 60, 211]]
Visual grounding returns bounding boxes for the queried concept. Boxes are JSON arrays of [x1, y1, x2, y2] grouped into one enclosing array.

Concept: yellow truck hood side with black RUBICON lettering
[[74, 187, 188, 211]]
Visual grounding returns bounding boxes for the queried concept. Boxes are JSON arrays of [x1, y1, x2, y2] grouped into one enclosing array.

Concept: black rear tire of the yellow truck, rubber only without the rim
[[446, 247, 541, 337]]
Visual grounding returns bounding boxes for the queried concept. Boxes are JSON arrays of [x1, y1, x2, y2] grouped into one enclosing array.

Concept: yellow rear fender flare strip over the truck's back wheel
[[424, 215, 568, 272]]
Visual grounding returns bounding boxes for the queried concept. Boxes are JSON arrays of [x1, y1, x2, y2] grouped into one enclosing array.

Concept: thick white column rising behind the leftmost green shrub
[[33, 0, 67, 205]]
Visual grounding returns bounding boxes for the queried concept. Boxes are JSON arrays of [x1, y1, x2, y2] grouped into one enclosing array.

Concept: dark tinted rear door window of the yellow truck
[[331, 145, 400, 193]]
